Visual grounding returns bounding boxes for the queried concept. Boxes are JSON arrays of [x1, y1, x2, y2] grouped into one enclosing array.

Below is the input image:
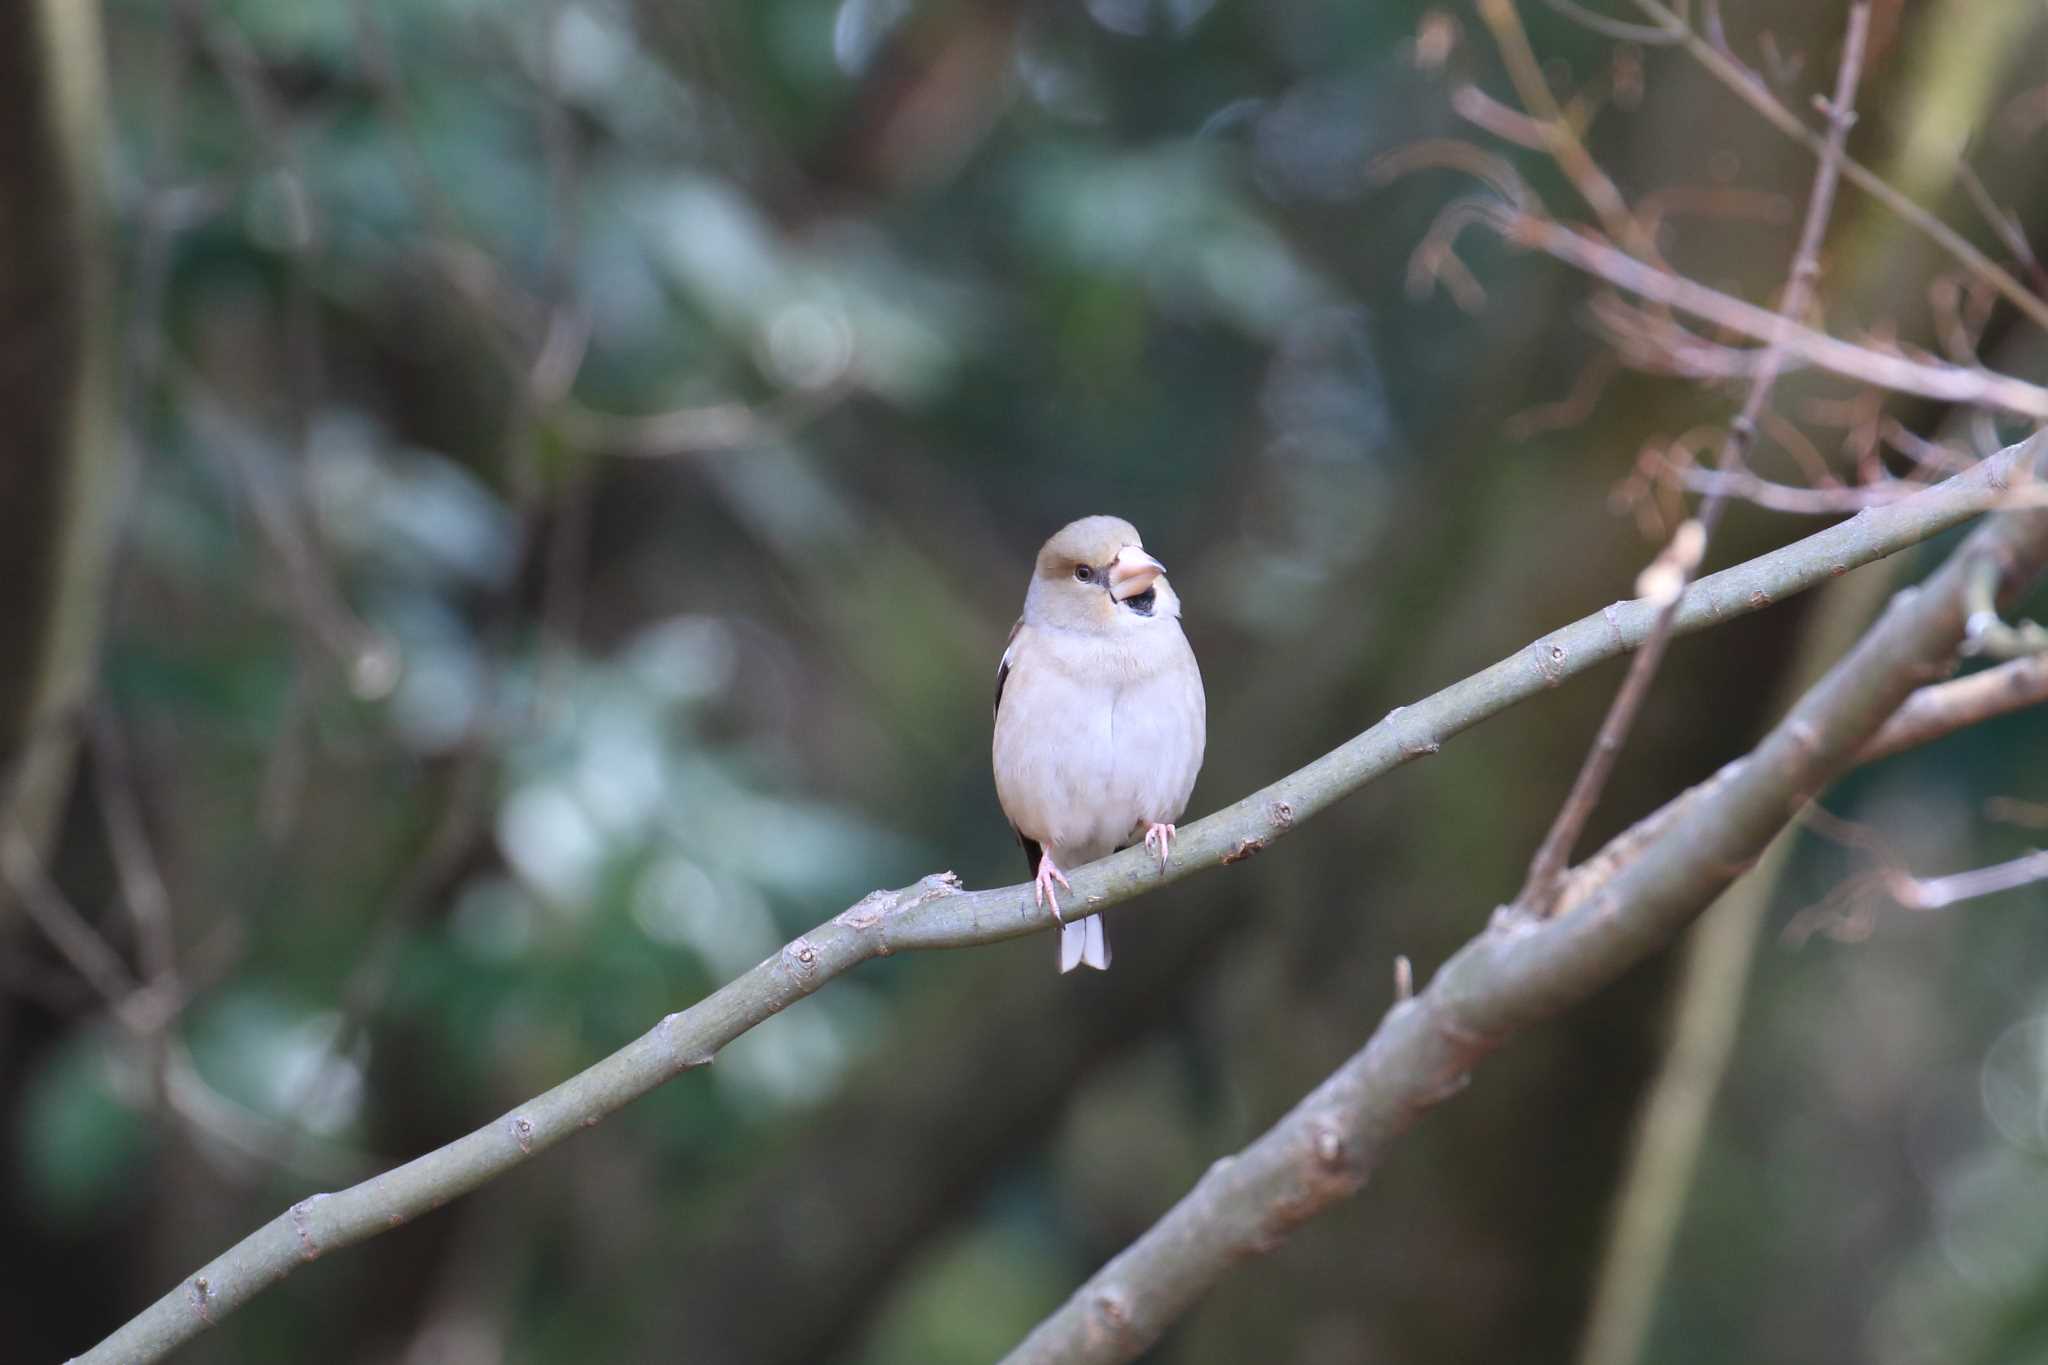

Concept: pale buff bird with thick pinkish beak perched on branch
[[993, 516, 1208, 972]]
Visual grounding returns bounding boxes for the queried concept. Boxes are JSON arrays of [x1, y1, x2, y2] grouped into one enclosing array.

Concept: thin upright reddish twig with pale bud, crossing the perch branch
[[1523, 0, 1870, 907]]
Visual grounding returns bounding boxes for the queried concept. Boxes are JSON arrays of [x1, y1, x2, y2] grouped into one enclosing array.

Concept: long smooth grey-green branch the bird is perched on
[[64, 438, 2048, 1361]]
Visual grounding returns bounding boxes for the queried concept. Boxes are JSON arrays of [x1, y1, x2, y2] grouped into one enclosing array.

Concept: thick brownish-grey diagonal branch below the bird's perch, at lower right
[[1008, 431, 2048, 1365]]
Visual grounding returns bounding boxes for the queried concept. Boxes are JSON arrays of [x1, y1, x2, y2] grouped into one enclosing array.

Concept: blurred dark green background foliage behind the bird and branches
[[0, 0, 2048, 1365]]
